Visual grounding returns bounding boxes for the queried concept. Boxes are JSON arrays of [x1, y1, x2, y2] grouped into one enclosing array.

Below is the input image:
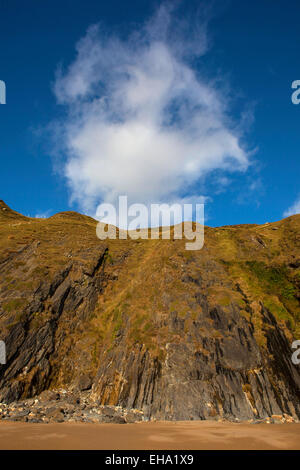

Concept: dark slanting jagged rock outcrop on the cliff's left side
[[0, 244, 106, 401]]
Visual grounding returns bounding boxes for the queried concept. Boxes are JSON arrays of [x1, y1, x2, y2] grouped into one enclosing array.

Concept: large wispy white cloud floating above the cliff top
[[54, 3, 248, 217]]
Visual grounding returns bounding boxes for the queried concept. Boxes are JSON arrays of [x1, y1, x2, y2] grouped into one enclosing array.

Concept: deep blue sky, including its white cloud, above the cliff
[[0, 0, 300, 226]]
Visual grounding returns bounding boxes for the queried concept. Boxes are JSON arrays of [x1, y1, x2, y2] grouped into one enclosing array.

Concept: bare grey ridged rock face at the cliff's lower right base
[[93, 307, 300, 420]]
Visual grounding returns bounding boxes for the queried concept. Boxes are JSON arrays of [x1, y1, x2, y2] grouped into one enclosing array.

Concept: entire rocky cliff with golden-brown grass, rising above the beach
[[0, 202, 300, 420]]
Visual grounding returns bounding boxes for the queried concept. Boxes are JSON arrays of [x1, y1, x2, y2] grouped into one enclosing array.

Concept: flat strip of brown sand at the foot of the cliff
[[0, 421, 300, 450]]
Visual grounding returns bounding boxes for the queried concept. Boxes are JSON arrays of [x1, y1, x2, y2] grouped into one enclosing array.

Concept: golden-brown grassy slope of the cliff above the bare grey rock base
[[0, 202, 300, 420]]
